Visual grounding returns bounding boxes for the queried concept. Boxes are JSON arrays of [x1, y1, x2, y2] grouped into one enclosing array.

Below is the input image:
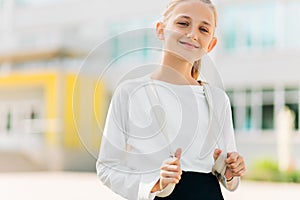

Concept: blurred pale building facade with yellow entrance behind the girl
[[0, 0, 300, 168]]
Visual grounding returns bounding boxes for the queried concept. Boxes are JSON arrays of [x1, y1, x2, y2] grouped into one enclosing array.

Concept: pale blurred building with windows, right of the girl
[[216, 0, 300, 168]]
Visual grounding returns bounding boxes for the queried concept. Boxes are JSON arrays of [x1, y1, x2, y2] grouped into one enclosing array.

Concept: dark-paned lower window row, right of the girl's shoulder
[[227, 87, 300, 131]]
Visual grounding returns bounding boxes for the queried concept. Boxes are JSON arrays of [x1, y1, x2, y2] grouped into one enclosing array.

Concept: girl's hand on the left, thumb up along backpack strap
[[151, 148, 182, 192]]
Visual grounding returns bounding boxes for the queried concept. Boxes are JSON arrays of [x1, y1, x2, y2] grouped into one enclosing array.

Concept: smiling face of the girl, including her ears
[[156, 0, 217, 63]]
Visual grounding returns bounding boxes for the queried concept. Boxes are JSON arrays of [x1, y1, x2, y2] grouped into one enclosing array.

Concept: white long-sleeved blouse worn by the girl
[[97, 74, 236, 200]]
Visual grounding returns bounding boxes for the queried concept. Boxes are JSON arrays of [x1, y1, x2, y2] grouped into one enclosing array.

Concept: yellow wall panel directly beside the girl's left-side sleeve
[[64, 74, 106, 151]]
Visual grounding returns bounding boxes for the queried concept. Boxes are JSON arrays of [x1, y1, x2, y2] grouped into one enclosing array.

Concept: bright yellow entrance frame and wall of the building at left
[[0, 71, 106, 149]]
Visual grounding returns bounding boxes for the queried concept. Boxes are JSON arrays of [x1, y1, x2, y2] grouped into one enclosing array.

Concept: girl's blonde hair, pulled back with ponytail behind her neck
[[162, 0, 218, 80]]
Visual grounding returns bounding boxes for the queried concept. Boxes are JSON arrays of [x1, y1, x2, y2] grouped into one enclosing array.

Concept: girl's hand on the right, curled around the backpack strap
[[214, 149, 246, 179]]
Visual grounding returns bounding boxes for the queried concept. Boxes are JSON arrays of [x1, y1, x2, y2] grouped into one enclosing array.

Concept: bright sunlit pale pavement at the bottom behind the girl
[[0, 172, 300, 200]]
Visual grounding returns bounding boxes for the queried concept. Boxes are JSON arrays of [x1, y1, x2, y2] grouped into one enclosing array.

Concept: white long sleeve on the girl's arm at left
[[96, 86, 159, 200]]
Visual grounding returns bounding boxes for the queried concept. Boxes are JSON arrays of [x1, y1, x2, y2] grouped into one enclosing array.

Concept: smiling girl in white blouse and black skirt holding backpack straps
[[97, 0, 246, 200]]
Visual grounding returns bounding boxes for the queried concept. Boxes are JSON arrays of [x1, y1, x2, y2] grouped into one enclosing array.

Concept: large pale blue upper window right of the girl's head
[[220, 1, 300, 52]]
